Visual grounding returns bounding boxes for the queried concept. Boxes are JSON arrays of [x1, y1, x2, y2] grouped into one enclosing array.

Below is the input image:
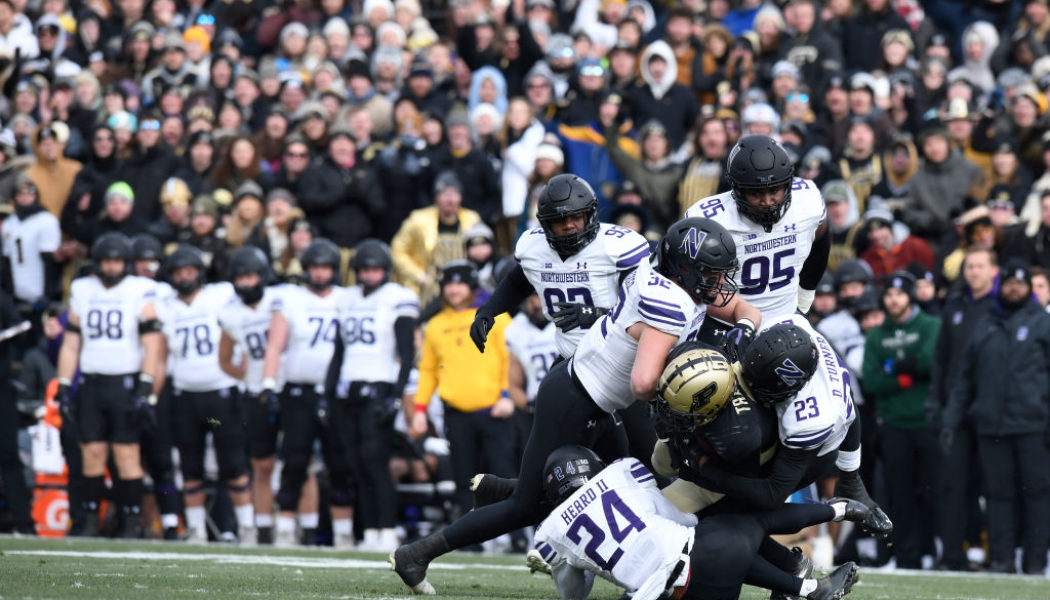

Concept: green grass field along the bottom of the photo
[[0, 537, 1050, 600]]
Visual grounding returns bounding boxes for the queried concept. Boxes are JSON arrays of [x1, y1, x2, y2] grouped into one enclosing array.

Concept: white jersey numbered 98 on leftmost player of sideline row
[[70, 277, 155, 375]]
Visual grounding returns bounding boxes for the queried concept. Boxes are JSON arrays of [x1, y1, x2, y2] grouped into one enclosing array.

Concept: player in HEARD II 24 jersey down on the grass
[[529, 447, 868, 600]]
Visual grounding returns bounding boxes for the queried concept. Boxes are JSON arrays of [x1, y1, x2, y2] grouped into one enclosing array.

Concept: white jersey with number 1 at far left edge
[[3, 210, 62, 302]]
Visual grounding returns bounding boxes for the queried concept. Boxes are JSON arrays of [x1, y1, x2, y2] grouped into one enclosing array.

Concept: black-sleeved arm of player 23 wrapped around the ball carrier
[[700, 447, 817, 511]]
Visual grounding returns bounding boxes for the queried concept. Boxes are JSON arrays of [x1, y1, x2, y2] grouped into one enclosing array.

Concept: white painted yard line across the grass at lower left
[[4, 550, 526, 571]]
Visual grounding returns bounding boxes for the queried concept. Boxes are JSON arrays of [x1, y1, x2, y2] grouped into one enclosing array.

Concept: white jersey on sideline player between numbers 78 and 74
[[218, 286, 285, 394]]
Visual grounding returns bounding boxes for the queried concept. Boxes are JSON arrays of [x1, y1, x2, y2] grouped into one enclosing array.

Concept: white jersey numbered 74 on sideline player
[[279, 286, 347, 386]]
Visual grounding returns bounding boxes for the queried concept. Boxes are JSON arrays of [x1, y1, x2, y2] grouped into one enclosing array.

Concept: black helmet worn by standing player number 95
[[727, 136, 795, 231]]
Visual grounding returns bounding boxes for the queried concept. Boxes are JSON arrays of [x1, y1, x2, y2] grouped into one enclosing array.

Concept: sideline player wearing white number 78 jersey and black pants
[[159, 245, 257, 544]]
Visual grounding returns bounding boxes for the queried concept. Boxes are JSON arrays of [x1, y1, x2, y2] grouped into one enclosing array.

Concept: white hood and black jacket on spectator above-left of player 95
[[628, 40, 699, 148]]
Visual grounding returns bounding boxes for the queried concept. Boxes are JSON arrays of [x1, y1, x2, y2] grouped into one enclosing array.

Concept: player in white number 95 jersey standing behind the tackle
[[686, 136, 832, 338]]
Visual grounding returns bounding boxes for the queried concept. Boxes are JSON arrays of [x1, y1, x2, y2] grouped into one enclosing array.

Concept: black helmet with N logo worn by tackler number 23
[[738, 323, 820, 406]]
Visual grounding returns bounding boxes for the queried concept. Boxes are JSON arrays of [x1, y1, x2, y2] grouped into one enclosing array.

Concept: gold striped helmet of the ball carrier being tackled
[[656, 347, 736, 431]]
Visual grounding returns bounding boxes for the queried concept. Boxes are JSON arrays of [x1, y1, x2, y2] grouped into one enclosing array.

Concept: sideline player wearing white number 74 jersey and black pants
[[261, 239, 354, 549]]
